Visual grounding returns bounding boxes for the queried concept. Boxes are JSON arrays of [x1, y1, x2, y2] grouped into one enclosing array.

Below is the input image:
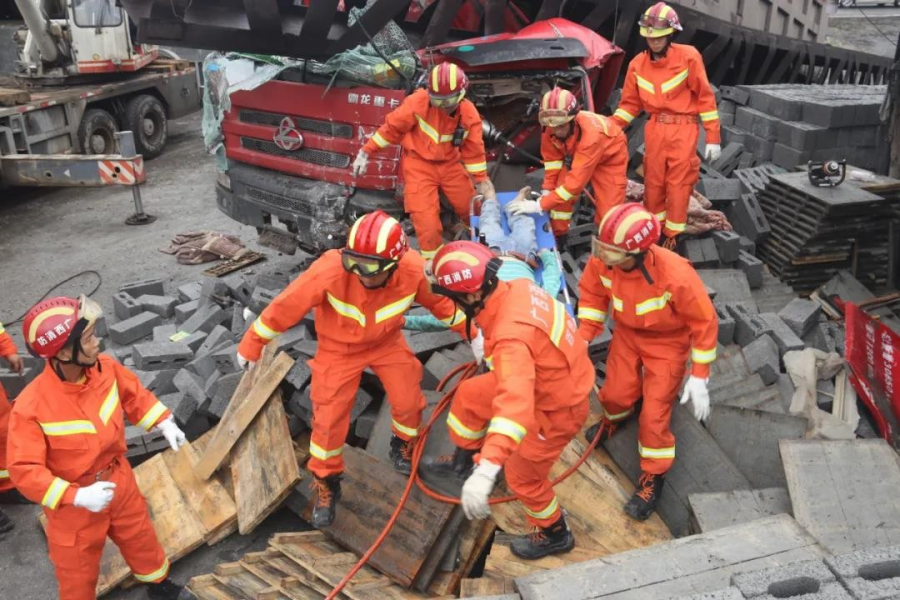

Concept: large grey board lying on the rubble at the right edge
[[779, 439, 900, 554]]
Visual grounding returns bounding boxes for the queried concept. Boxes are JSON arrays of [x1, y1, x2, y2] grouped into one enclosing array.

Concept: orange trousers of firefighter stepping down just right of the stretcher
[[600, 323, 690, 475]]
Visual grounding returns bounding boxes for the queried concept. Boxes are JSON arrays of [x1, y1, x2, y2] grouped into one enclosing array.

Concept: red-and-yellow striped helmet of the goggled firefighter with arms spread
[[342, 210, 409, 275]]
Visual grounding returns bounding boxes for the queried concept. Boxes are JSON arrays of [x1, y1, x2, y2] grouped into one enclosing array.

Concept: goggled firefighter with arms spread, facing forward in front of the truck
[[238, 211, 478, 528]]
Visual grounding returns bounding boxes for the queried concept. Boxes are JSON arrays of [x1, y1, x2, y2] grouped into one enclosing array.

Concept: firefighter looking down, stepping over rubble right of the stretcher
[[578, 203, 718, 520]]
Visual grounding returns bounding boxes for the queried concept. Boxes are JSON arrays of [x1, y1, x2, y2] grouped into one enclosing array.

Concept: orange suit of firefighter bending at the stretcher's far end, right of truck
[[541, 111, 628, 236]]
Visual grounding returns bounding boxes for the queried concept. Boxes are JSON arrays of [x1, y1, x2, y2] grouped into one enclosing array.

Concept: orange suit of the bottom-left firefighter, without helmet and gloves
[[7, 354, 171, 600]]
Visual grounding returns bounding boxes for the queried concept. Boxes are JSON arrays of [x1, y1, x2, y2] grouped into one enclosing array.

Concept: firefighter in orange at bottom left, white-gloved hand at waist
[[7, 296, 185, 600]]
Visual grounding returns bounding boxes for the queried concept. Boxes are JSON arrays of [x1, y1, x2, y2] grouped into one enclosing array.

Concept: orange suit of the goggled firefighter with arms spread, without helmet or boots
[[238, 250, 465, 479]]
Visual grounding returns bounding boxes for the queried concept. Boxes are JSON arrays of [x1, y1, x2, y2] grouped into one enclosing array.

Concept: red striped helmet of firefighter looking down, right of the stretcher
[[592, 202, 661, 265]]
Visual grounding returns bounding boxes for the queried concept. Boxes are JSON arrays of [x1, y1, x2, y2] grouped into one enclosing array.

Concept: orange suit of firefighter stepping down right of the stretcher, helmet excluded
[[578, 247, 719, 475]]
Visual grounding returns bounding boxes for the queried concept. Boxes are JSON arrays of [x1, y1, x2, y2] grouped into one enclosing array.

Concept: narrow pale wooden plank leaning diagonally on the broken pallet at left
[[196, 352, 294, 479]]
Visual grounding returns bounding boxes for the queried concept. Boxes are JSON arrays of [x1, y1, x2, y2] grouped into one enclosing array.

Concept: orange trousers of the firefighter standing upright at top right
[[644, 119, 700, 237]]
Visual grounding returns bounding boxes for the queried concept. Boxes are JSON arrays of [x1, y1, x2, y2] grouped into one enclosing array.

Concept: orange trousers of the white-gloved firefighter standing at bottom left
[[44, 457, 169, 600]]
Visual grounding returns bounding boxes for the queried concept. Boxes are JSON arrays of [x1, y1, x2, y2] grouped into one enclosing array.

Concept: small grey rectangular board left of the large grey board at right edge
[[688, 488, 791, 533]]
